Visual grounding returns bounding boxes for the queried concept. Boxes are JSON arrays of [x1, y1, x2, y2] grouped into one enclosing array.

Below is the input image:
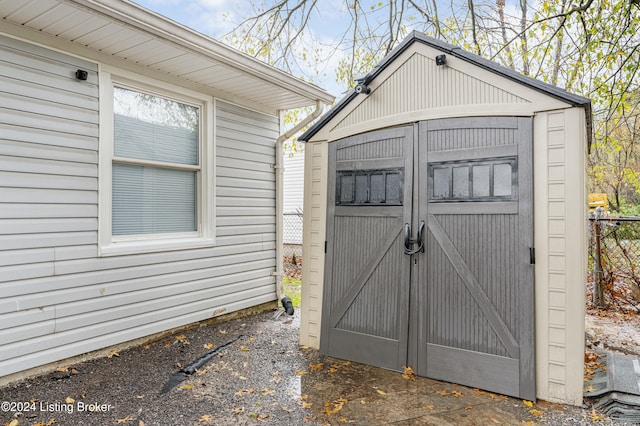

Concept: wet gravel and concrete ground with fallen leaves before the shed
[[0, 312, 624, 426]]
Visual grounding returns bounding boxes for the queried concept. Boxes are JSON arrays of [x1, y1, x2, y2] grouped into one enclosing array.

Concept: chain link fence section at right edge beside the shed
[[589, 214, 640, 310]]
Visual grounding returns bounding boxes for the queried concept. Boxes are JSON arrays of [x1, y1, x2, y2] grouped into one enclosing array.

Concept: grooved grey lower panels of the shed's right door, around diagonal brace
[[425, 215, 519, 356]]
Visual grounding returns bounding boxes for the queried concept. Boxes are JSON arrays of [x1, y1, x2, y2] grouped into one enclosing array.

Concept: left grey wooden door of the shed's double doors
[[320, 126, 414, 369]]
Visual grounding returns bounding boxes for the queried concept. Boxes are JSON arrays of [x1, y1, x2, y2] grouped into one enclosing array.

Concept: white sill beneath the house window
[[99, 237, 215, 257]]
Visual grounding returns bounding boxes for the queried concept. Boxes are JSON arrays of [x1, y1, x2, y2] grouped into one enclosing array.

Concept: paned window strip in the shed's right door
[[428, 157, 518, 202]]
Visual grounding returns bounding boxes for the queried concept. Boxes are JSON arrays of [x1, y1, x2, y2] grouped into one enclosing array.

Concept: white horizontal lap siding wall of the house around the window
[[0, 36, 279, 376]]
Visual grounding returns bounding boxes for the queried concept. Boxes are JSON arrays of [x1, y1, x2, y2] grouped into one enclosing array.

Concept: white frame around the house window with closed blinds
[[98, 65, 216, 256]]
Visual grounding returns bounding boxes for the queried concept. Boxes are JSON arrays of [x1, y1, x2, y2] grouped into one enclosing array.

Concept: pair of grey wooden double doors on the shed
[[321, 117, 535, 400]]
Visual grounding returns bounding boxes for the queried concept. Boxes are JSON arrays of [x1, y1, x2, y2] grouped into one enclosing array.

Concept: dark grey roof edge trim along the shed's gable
[[299, 31, 591, 145]]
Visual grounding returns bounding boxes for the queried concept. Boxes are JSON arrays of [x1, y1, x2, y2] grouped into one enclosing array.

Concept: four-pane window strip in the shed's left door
[[336, 169, 403, 206]]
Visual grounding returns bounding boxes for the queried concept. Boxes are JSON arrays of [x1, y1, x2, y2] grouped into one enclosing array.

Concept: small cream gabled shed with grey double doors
[[300, 32, 591, 404]]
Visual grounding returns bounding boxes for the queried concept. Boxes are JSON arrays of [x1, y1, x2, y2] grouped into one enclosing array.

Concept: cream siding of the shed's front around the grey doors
[[300, 43, 586, 405]]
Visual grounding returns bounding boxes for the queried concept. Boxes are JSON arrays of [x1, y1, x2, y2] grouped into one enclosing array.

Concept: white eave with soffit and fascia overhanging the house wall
[[0, 0, 334, 111]]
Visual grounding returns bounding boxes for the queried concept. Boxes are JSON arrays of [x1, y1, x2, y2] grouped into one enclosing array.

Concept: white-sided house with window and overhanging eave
[[0, 0, 333, 381]]
